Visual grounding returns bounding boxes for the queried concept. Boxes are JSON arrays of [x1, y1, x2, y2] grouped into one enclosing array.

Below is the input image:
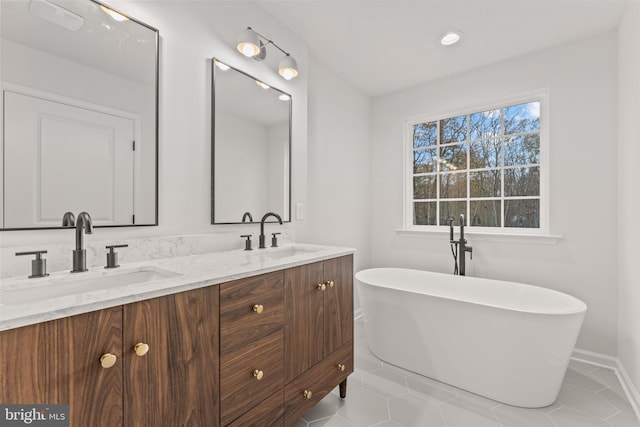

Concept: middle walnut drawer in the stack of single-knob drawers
[[220, 329, 284, 425]]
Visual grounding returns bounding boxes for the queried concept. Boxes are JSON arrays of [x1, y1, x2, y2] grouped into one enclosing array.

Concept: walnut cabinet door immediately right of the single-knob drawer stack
[[284, 262, 325, 382]]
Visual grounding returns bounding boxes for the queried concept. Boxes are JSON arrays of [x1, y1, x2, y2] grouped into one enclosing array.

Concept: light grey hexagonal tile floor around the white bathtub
[[296, 321, 640, 427]]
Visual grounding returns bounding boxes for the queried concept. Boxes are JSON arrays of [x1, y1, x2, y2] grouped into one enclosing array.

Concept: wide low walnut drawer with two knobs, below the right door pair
[[284, 342, 353, 426]]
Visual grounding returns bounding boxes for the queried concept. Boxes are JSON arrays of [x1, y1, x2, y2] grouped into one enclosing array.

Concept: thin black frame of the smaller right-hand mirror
[[211, 57, 293, 225]]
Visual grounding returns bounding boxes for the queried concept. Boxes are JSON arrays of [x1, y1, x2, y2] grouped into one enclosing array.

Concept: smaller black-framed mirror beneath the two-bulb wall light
[[211, 58, 292, 224]]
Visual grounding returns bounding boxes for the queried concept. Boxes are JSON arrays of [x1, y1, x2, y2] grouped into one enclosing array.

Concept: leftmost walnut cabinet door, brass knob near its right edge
[[0, 307, 122, 427]]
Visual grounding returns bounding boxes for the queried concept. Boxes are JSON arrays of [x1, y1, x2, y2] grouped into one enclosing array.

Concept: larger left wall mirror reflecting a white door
[[0, 0, 159, 230]]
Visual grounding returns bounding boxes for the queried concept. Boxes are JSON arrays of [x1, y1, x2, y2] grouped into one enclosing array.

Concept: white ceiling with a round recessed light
[[255, 0, 640, 96]]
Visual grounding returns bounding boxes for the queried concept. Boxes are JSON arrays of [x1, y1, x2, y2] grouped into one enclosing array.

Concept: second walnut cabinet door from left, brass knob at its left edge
[[123, 287, 219, 427]]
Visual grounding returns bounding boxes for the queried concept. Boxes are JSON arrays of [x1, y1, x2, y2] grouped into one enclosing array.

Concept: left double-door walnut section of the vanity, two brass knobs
[[0, 287, 219, 427]]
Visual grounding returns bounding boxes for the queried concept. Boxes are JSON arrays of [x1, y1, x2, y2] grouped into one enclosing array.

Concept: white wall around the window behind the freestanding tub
[[371, 33, 620, 355]]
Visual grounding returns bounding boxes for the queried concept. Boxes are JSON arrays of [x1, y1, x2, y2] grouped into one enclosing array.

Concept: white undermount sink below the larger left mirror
[[0, 267, 180, 305]]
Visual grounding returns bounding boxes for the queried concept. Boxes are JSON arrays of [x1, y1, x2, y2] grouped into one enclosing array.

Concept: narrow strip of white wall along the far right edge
[[618, 2, 640, 398]]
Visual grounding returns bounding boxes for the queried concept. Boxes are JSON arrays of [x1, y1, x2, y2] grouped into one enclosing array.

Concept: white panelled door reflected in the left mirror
[[4, 91, 134, 228]]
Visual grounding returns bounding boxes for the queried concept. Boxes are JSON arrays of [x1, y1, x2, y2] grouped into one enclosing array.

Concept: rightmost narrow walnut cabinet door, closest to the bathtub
[[324, 255, 353, 357]]
